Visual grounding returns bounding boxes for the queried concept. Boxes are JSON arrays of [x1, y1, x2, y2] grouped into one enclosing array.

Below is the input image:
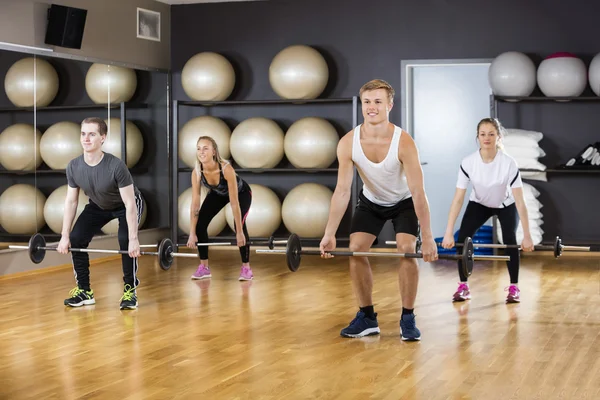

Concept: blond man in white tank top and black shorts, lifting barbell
[[320, 79, 438, 340]]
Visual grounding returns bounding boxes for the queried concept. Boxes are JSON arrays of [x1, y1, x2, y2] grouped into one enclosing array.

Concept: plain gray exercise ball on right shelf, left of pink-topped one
[[488, 51, 536, 97]]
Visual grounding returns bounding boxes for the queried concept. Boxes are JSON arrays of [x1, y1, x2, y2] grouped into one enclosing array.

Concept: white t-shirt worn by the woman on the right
[[456, 150, 523, 208]]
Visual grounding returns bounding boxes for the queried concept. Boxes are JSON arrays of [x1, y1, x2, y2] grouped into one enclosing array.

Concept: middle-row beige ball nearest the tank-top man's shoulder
[[283, 117, 340, 168]]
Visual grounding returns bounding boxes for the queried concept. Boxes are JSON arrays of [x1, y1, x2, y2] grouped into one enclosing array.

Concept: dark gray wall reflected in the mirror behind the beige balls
[[0, 50, 169, 241]]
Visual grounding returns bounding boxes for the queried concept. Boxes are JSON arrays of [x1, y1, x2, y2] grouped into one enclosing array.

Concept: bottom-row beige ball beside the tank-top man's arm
[[281, 183, 333, 238]]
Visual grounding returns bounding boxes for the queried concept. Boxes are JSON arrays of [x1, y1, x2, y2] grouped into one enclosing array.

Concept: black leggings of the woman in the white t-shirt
[[456, 201, 520, 283]]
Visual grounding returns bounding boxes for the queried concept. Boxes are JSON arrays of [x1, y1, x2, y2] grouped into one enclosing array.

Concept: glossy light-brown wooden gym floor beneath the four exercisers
[[0, 249, 600, 400]]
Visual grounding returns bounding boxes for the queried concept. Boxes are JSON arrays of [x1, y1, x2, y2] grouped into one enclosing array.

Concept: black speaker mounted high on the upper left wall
[[44, 4, 87, 49]]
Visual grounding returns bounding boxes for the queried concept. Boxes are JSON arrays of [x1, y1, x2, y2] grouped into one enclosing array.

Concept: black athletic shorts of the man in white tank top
[[350, 190, 420, 237]]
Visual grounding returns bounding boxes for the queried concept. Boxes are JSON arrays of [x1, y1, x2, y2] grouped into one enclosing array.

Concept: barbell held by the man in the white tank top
[[256, 233, 510, 276]]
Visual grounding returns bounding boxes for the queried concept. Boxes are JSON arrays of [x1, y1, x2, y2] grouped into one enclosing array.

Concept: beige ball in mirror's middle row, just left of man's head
[[40, 121, 83, 169]]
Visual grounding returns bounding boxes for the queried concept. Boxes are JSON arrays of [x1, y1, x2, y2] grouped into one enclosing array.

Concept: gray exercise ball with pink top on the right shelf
[[537, 53, 587, 97]]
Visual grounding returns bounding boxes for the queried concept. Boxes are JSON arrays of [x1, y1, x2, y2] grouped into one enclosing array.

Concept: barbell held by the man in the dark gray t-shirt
[[8, 233, 198, 271]]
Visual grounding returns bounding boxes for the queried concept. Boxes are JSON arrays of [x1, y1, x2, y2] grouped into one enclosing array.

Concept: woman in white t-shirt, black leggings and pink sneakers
[[442, 118, 533, 303]]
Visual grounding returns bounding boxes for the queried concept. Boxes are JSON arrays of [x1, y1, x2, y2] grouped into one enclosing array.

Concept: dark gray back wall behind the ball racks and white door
[[171, 0, 600, 245]]
